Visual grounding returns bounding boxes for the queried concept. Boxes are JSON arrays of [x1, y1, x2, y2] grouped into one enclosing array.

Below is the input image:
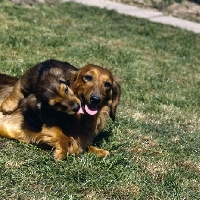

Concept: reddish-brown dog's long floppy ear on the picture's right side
[[109, 76, 122, 121]]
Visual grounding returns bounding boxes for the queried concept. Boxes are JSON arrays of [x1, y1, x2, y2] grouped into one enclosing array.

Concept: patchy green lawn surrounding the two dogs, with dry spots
[[0, 1, 200, 200]]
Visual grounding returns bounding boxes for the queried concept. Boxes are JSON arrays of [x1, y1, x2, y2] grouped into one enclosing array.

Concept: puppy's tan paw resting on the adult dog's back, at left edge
[[0, 99, 18, 115]]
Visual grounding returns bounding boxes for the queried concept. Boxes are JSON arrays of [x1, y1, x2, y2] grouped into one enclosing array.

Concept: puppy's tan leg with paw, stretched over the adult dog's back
[[0, 80, 24, 114]]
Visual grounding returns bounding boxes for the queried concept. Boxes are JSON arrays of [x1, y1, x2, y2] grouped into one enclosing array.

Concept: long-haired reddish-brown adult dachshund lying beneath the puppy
[[0, 60, 121, 160]]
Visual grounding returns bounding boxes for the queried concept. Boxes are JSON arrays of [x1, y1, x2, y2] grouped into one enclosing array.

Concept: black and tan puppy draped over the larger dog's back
[[1, 60, 80, 114]]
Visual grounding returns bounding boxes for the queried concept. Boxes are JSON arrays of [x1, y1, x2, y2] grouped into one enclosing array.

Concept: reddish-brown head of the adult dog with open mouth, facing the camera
[[70, 64, 121, 120]]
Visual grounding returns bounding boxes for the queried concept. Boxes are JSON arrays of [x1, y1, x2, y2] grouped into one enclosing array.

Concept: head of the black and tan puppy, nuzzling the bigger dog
[[36, 75, 81, 114]]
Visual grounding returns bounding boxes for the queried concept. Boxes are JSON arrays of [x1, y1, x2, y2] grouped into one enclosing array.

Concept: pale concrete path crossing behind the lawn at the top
[[63, 0, 200, 33]]
